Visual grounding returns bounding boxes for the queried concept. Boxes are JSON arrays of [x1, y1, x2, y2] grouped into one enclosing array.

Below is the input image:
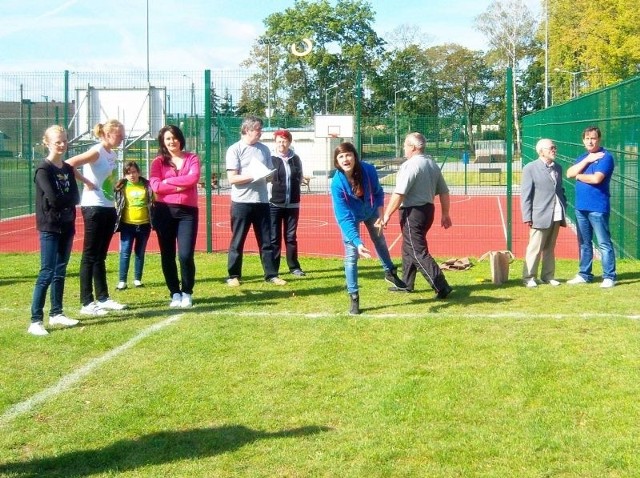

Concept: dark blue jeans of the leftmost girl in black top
[[31, 229, 75, 322]]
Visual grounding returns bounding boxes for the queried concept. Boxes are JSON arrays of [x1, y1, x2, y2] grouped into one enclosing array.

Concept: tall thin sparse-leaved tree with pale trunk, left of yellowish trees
[[476, 0, 536, 150]]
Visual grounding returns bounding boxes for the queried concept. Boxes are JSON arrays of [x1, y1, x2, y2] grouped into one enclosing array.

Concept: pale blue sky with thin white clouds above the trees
[[0, 0, 541, 72]]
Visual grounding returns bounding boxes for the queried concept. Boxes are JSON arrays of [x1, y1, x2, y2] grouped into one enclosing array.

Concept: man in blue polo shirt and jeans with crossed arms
[[567, 126, 616, 288]]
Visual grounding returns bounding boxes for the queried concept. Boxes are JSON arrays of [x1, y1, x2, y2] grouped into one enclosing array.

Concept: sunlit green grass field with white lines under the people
[[0, 254, 640, 477]]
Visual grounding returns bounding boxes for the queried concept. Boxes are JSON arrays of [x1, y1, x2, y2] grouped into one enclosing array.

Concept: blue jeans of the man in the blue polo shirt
[[576, 209, 616, 282]]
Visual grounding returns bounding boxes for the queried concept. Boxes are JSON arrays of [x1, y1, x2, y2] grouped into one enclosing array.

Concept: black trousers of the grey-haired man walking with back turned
[[400, 203, 448, 294]]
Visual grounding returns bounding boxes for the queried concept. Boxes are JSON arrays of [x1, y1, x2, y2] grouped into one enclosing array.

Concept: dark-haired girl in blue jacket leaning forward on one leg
[[331, 142, 406, 315]]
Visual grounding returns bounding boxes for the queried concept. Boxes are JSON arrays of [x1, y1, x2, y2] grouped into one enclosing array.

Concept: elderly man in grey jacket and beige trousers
[[520, 138, 567, 287]]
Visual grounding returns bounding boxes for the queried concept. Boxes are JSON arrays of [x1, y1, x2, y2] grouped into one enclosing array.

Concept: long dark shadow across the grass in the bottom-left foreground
[[0, 425, 331, 477]]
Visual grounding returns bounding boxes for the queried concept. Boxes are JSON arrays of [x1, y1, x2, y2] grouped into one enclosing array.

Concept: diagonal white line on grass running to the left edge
[[0, 315, 182, 426]]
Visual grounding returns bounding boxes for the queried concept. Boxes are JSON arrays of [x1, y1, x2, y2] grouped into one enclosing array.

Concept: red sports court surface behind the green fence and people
[[0, 194, 578, 259]]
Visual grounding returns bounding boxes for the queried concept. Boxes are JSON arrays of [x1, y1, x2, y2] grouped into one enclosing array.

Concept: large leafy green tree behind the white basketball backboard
[[244, 0, 384, 117]]
